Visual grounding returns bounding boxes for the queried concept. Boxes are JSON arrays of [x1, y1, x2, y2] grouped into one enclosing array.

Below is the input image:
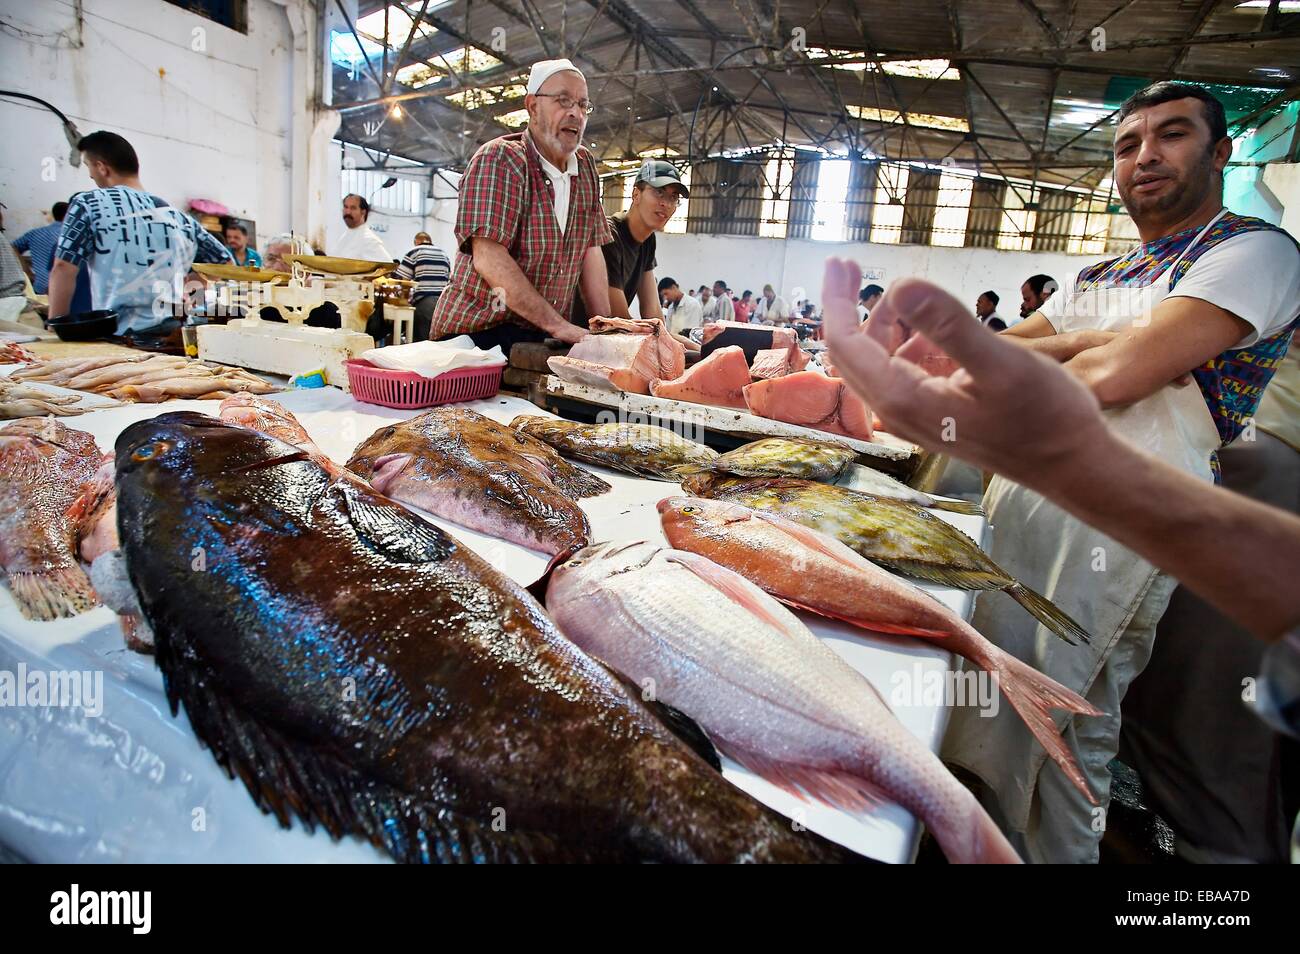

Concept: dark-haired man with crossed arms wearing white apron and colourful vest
[[943, 83, 1300, 862]]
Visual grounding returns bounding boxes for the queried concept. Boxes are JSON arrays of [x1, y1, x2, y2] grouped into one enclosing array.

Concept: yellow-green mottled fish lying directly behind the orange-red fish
[[681, 474, 1092, 643]]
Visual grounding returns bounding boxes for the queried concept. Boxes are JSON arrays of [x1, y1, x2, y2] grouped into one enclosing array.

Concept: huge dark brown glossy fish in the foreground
[[117, 413, 855, 862]]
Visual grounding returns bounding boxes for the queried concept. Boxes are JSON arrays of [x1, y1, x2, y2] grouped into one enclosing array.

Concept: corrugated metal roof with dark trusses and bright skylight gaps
[[333, 0, 1300, 183]]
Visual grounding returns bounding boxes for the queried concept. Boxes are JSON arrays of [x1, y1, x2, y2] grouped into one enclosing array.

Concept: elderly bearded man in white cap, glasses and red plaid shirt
[[430, 60, 614, 354]]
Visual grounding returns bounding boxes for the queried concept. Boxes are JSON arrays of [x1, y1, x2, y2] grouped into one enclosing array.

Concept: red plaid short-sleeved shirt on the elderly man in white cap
[[430, 131, 614, 338]]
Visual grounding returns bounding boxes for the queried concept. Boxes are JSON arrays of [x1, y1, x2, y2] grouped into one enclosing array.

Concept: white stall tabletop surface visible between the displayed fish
[[0, 370, 1001, 862]]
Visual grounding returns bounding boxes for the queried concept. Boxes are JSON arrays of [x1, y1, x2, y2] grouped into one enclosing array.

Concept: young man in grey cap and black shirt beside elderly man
[[571, 160, 690, 328]]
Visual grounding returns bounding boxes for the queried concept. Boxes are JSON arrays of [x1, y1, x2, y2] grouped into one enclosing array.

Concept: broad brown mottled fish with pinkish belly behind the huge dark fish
[[347, 404, 610, 556]]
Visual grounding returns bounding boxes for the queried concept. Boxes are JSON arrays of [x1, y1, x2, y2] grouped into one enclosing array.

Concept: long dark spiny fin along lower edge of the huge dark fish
[[156, 638, 575, 863]]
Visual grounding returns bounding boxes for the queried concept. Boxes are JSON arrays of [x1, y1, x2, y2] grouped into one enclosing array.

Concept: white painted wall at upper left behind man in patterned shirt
[[0, 0, 297, 240]]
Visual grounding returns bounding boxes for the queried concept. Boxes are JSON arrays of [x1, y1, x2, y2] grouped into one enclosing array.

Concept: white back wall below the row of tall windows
[[655, 234, 1108, 317]]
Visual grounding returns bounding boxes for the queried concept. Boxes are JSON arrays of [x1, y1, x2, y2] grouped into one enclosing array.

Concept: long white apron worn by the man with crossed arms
[[943, 209, 1226, 860]]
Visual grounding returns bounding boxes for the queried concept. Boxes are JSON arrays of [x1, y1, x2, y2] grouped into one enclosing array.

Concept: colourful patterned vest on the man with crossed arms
[[1058, 212, 1300, 482]]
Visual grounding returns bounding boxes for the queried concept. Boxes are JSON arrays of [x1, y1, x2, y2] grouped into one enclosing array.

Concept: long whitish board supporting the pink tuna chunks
[[534, 374, 930, 481]]
